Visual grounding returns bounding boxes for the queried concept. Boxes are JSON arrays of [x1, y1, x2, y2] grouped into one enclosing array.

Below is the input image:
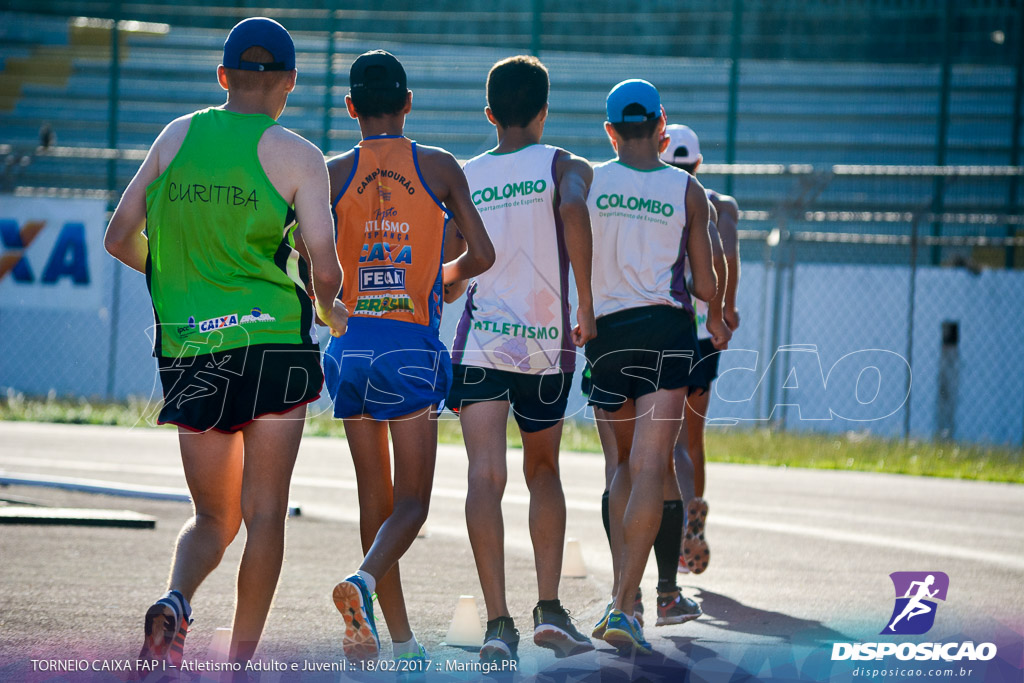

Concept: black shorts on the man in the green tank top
[[157, 344, 324, 433]]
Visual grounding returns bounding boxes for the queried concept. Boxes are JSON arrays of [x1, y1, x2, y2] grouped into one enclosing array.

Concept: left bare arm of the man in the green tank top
[[103, 115, 191, 272]]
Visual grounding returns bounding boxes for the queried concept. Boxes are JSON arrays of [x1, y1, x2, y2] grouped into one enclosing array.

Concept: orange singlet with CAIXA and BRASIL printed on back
[[334, 135, 449, 331]]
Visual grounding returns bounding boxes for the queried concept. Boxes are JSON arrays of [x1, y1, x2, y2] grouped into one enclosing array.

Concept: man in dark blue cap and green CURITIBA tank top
[[104, 17, 347, 671]]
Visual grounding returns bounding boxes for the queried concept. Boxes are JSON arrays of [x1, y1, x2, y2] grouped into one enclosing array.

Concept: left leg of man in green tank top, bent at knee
[[167, 428, 242, 601]]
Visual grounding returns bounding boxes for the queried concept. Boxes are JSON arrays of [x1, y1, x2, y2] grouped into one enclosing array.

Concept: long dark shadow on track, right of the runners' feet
[[696, 589, 851, 645]]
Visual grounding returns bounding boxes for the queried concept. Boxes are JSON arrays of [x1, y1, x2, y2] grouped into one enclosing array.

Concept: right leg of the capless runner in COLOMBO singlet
[[520, 420, 565, 600]]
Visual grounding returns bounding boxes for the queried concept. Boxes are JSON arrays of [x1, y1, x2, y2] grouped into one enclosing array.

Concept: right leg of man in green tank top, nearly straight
[[231, 405, 306, 661]]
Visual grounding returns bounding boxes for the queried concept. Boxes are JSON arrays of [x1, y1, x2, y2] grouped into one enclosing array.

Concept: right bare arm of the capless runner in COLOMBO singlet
[[555, 151, 597, 347]]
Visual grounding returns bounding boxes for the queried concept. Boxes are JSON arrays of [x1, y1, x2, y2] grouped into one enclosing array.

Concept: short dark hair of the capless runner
[[487, 54, 550, 128]]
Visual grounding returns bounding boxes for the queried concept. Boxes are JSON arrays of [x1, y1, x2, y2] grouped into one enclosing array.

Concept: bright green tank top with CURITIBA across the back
[[145, 109, 313, 357]]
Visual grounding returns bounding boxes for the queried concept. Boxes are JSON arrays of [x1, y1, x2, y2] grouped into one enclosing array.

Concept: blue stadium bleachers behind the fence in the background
[[0, 13, 1014, 266]]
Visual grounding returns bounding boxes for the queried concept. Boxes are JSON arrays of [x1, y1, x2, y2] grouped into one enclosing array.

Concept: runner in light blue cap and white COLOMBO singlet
[[586, 79, 726, 653]]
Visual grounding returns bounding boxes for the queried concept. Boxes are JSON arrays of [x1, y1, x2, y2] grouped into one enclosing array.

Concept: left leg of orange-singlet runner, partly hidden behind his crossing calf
[[345, 416, 412, 642]]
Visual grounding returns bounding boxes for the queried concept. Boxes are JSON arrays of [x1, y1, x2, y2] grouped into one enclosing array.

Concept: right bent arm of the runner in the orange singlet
[[417, 145, 495, 285]]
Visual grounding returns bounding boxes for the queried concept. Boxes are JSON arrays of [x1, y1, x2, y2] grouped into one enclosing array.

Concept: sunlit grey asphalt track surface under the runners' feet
[[0, 422, 1024, 681]]
